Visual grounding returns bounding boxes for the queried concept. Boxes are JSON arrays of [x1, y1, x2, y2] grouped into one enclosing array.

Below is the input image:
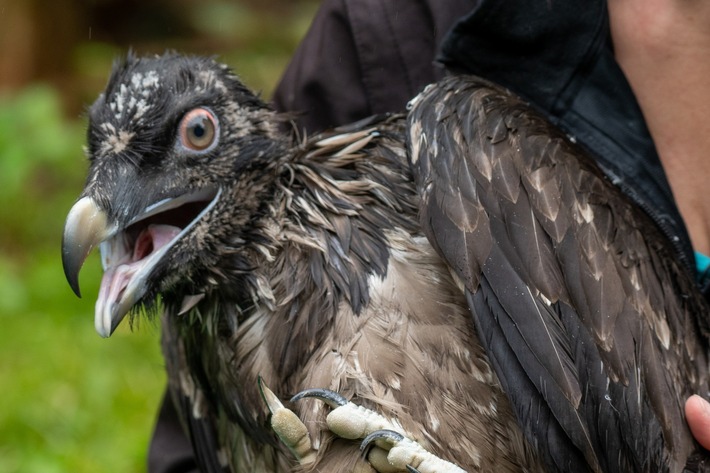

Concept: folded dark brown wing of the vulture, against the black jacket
[[408, 77, 708, 471]]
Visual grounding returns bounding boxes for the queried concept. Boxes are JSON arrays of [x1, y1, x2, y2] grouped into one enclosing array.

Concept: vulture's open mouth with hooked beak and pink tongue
[[63, 189, 221, 337]]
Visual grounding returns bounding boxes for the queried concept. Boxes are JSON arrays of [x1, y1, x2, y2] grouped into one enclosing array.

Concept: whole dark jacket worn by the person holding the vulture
[[149, 0, 710, 473]]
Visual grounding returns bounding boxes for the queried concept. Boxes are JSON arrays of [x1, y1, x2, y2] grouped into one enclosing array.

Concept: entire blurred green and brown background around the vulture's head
[[0, 0, 317, 473]]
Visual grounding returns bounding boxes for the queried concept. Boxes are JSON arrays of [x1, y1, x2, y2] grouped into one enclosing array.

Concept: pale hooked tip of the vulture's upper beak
[[62, 197, 116, 297]]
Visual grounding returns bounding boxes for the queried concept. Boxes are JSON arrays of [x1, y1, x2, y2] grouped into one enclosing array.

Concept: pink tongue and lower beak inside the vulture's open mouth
[[96, 224, 182, 330]]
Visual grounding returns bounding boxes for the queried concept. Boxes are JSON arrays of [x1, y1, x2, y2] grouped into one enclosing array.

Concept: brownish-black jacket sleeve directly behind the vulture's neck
[[274, 0, 477, 132]]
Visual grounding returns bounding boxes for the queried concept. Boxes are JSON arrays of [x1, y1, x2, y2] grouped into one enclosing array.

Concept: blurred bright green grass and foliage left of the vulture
[[0, 85, 165, 473]]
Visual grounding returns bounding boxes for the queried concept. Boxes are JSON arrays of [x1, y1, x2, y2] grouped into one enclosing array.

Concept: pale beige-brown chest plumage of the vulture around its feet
[[167, 226, 542, 472]]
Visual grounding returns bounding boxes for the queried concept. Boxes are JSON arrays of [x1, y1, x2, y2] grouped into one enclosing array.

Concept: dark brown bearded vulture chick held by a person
[[63, 53, 709, 473]]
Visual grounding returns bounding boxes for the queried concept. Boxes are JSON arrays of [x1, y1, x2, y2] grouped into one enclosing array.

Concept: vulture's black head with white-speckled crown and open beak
[[62, 53, 284, 337]]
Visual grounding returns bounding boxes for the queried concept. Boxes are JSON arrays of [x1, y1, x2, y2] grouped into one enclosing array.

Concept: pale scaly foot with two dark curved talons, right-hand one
[[291, 389, 466, 473]]
